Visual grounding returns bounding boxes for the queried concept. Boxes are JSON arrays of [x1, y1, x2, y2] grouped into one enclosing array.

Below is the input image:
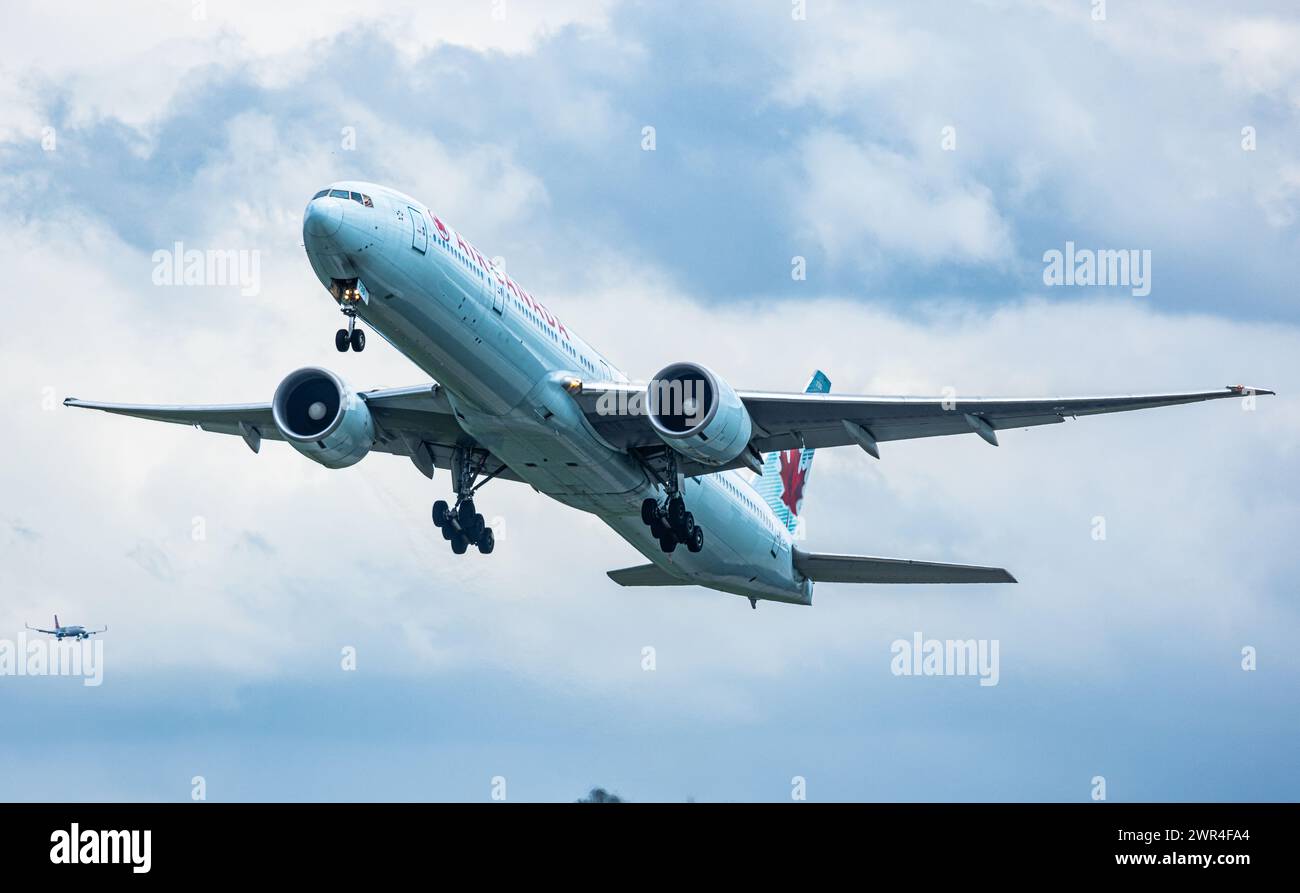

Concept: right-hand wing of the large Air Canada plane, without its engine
[[577, 382, 1273, 474]]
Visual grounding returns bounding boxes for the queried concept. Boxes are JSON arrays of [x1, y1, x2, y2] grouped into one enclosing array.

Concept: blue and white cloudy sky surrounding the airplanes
[[0, 0, 1300, 801]]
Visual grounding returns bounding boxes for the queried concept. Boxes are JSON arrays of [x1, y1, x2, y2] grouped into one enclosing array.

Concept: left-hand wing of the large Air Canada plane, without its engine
[[64, 385, 520, 481]]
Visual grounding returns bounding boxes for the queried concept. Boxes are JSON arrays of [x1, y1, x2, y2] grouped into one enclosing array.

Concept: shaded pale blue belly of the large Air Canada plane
[[335, 233, 807, 603]]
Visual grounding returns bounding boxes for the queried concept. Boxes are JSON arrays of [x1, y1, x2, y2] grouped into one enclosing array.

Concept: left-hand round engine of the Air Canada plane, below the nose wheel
[[270, 367, 374, 468]]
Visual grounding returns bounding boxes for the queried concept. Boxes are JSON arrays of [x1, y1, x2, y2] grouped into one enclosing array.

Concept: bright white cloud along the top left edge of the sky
[[0, 0, 612, 138]]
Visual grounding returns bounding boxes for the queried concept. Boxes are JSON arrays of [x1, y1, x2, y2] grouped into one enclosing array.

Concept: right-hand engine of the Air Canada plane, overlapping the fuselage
[[646, 363, 754, 465]]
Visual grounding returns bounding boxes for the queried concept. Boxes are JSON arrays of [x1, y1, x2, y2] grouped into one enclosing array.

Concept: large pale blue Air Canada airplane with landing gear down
[[65, 182, 1273, 607]]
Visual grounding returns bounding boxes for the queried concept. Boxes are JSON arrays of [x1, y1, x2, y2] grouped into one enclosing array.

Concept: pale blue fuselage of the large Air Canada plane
[[303, 182, 813, 604]]
